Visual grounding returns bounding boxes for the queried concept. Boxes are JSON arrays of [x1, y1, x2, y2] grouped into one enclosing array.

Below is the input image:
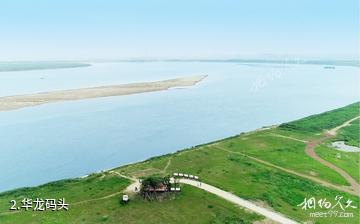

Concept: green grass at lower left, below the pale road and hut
[[0, 173, 262, 224]]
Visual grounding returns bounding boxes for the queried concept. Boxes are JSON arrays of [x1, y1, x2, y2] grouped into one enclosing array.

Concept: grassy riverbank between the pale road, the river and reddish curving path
[[118, 103, 359, 223]]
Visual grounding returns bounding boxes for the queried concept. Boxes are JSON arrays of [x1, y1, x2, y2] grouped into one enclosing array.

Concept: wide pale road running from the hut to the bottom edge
[[179, 179, 297, 224]]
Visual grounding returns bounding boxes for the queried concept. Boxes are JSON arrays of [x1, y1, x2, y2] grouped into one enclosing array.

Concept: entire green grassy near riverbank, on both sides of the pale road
[[0, 103, 360, 223]]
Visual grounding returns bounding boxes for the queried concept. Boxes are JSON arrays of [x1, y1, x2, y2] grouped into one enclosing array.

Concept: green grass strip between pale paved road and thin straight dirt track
[[119, 143, 360, 223]]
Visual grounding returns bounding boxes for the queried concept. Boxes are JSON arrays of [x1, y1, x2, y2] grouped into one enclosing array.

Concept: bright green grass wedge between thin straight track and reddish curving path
[[219, 130, 348, 185]]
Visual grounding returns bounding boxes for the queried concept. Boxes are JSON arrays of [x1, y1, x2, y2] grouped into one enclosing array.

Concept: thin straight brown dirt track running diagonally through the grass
[[213, 145, 358, 195]]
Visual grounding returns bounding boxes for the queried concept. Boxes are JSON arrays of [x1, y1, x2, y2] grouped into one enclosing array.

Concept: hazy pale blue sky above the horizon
[[0, 0, 359, 60]]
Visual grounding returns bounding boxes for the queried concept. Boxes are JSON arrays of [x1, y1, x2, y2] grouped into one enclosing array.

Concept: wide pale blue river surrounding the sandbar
[[0, 62, 360, 191]]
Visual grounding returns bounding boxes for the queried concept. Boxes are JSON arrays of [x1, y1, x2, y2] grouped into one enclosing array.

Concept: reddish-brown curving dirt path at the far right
[[305, 116, 360, 195]]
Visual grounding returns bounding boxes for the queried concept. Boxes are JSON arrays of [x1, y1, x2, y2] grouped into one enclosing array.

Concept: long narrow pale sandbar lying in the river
[[0, 75, 207, 111]]
